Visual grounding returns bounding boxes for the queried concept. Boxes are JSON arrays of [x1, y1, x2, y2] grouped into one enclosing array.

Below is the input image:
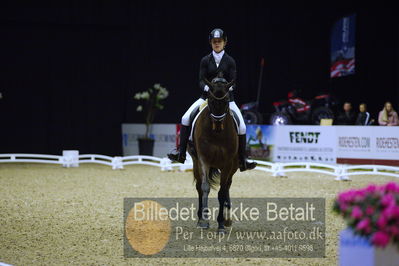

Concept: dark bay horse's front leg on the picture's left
[[197, 161, 210, 229]]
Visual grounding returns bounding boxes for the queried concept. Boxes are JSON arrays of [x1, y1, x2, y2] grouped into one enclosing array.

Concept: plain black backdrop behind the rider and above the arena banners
[[0, 1, 399, 155]]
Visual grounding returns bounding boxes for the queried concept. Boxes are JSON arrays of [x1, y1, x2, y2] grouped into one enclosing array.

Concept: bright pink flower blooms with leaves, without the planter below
[[333, 182, 399, 248]]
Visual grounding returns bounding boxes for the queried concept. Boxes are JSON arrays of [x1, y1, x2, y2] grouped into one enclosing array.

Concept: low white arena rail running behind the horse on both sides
[[0, 153, 399, 180]]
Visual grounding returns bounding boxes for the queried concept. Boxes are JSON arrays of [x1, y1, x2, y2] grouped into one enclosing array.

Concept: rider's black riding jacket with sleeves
[[199, 51, 237, 101]]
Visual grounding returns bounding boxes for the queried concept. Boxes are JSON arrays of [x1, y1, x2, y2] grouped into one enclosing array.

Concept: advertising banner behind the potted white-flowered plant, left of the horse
[[122, 124, 176, 158]]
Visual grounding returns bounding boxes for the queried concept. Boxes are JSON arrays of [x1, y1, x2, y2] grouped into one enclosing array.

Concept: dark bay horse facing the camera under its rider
[[189, 79, 238, 233]]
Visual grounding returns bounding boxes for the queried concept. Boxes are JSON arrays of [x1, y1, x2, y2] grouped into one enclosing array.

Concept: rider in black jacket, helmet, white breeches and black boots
[[168, 28, 256, 171]]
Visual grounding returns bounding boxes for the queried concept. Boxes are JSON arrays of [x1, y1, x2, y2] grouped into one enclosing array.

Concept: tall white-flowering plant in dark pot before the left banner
[[134, 83, 169, 155]]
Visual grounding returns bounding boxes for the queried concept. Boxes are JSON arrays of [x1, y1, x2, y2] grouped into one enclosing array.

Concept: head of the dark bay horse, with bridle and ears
[[204, 76, 234, 131]]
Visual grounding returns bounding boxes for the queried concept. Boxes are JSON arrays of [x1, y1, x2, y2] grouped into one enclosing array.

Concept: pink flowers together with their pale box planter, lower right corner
[[333, 182, 399, 265]]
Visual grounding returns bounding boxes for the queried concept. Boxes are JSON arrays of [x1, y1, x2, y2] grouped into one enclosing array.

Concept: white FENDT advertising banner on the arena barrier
[[273, 126, 336, 163]]
